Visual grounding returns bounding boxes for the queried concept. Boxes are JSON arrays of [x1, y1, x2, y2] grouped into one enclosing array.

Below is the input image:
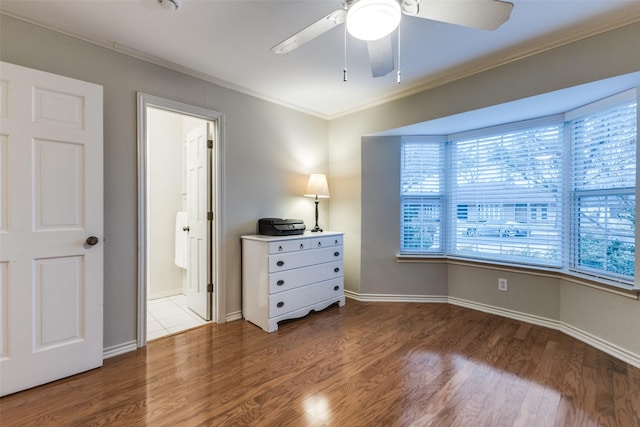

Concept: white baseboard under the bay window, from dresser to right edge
[[345, 291, 640, 369]]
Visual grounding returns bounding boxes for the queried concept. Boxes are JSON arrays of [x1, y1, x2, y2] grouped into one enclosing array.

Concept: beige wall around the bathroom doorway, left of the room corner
[[0, 15, 329, 348]]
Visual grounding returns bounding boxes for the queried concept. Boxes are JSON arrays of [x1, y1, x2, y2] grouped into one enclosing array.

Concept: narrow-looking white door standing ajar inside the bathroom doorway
[[187, 121, 213, 320]]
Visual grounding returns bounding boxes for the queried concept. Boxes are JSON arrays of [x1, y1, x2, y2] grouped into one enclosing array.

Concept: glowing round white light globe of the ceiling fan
[[347, 0, 402, 41]]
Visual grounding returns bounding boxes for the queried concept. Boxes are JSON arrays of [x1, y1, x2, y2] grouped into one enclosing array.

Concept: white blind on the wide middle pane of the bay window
[[449, 117, 564, 267]]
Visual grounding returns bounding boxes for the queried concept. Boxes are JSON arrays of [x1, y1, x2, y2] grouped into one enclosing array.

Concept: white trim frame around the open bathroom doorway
[[137, 92, 226, 348]]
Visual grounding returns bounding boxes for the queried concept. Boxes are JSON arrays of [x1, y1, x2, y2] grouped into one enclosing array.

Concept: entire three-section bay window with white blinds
[[400, 90, 638, 285]]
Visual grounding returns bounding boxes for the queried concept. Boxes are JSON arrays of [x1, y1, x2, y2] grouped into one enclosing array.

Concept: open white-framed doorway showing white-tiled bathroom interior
[[138, 94, 222, 347]]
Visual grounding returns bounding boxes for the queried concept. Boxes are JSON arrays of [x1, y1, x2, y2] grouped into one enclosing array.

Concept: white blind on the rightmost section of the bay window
[[570, 96, 637, 282]]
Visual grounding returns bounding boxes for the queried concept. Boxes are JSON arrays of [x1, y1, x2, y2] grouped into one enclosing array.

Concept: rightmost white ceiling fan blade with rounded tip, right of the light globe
[[402, 0, 513, 30]]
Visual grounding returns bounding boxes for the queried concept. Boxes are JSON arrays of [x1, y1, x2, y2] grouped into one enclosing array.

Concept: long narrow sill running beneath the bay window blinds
[[396, 255, 640, 300]]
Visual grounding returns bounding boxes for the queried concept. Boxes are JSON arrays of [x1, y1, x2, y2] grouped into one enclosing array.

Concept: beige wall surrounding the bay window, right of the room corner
[[329, 23, 640, 361]]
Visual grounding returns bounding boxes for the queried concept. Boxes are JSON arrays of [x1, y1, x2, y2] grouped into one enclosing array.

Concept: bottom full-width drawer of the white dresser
[[269, 278, 343, 317]]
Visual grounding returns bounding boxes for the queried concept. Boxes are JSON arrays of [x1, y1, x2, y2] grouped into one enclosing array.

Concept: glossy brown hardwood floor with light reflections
[[0, 300, 640, 427]]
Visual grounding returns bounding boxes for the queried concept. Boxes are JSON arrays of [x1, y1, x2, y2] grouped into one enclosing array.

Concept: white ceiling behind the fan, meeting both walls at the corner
[[0, 0, 640, 118]]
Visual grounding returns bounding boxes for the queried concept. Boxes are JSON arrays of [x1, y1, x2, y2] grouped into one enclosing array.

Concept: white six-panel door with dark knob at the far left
[[0, 62, 103, 395]]
